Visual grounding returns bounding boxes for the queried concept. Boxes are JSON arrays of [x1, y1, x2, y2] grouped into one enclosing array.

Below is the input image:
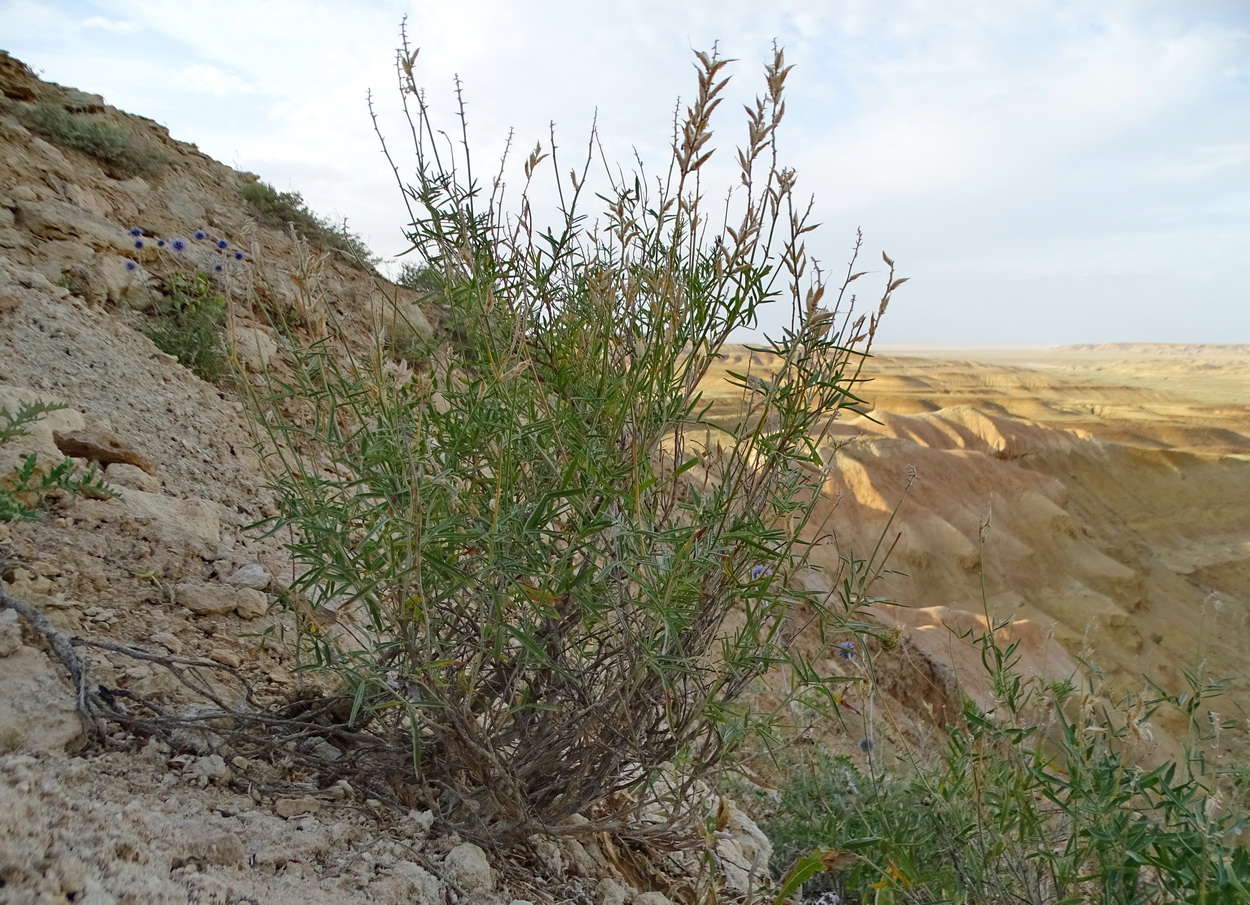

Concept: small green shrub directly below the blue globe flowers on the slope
[[145, 273, 230, 383]]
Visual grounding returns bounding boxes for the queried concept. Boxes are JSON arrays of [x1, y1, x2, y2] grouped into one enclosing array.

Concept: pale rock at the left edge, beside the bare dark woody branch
[[0, 646, 83, 753]]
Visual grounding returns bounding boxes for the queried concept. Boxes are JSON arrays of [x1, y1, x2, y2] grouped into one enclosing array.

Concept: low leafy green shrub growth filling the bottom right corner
[[765, 622, 1250, 905]]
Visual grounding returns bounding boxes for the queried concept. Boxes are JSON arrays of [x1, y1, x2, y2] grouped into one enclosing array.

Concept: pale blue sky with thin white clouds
[[0, 0, 1250, 345]]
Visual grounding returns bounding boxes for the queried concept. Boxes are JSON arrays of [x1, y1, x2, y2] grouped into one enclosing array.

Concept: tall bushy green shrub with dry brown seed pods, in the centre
[[253, 40, 903, 840]]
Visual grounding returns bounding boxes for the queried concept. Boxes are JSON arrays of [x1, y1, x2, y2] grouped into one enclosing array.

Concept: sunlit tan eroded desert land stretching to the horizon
[[705, 344, 1250, 759]]
